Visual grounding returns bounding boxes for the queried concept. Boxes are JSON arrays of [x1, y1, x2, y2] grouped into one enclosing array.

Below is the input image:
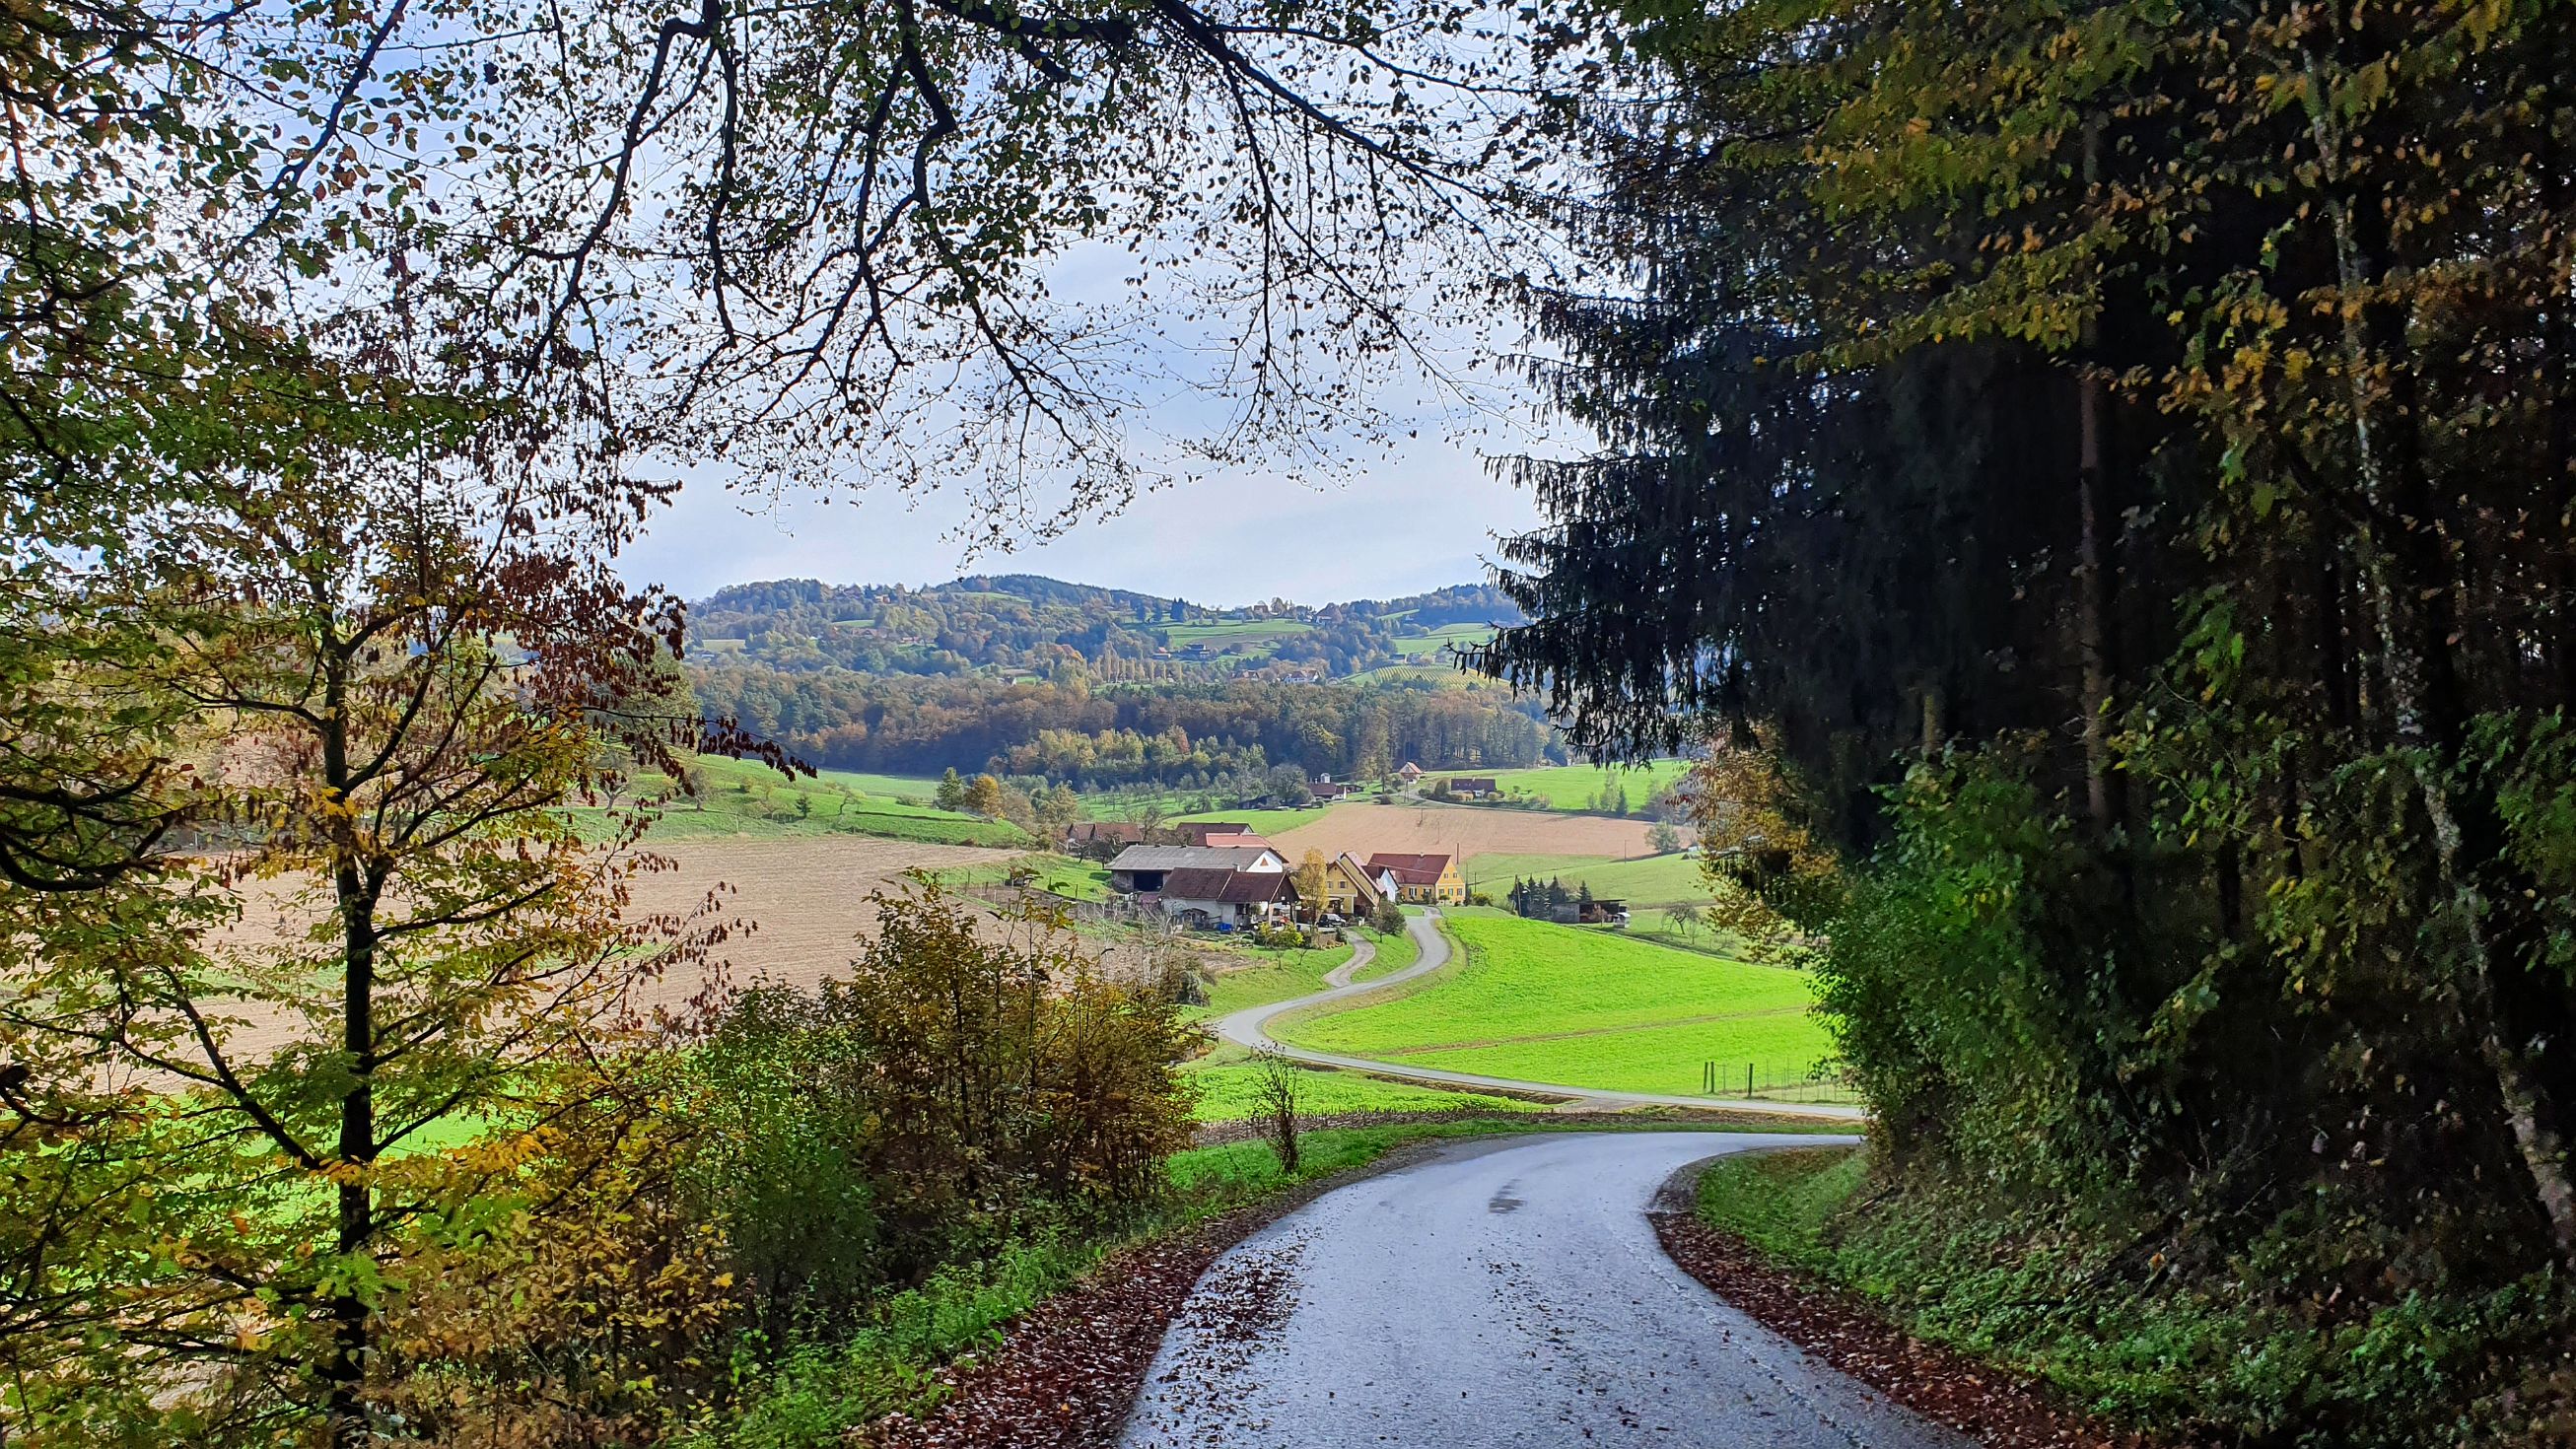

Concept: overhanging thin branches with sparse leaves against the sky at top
[[55, 0, 1571, 543]]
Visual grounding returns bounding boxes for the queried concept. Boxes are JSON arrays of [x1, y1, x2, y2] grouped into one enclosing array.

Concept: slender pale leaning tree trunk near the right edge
[[2306, 54, 2576, 1264]]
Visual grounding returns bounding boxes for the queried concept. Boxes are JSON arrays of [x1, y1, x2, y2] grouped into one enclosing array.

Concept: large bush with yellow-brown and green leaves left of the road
[[371, 885, 1190, 1449]]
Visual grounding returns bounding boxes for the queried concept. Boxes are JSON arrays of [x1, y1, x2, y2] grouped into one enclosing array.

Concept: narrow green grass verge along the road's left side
[[705, 1117, 1780, 1449]]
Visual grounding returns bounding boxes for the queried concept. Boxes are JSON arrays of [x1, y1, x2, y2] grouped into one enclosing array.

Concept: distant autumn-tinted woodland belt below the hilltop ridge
[[693, 664, 1561, 791]]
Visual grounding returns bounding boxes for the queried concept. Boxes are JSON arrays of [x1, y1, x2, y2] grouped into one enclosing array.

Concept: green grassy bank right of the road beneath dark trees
[[1698, 1148, 2576, 1449]]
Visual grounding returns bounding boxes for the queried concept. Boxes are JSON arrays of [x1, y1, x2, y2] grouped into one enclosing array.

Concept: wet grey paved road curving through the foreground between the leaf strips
[[1121, 1133, 1966, 1449]]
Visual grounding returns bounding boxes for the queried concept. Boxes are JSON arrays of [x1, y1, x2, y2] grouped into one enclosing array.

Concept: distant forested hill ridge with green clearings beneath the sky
[[690, 574, 1525, 682]]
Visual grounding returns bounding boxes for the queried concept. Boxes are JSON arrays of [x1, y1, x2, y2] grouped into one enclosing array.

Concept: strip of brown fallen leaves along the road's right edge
[[1646, 1145, 2159, 1449]]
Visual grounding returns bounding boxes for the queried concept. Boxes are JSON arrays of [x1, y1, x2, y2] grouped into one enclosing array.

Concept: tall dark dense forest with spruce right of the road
[[1484, 3, 2576, 1444]]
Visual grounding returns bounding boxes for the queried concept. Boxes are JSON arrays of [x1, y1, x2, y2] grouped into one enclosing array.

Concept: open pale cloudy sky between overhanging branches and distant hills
[[621, 31, 1584, 607]]
